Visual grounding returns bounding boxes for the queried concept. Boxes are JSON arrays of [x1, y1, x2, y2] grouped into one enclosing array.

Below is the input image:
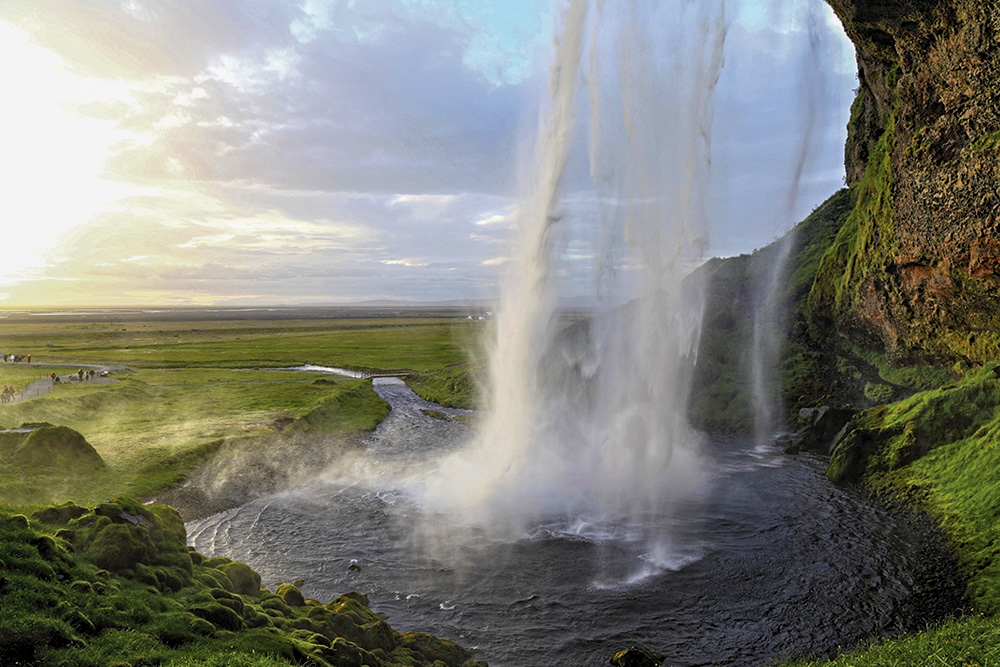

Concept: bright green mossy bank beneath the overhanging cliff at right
[[827, 362, 1000, 613]]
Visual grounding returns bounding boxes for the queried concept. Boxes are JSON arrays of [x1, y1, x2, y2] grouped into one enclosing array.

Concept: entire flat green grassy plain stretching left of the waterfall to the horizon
[[0, 316, 481, 504]]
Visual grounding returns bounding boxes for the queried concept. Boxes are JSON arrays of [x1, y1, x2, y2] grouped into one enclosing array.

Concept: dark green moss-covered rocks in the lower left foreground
[[0, 498, 480, 667]]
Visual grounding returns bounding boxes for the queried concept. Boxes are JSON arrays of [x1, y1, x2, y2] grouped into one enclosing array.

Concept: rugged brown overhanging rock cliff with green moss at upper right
[[810, 0, 1000, 362]]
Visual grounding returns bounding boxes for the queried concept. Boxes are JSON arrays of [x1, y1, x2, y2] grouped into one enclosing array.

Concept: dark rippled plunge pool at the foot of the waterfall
[[188, 384, 960, 667]]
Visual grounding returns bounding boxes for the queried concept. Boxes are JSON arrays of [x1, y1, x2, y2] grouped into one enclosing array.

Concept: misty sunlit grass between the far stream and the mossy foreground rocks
[[0, 369, 388, 502]]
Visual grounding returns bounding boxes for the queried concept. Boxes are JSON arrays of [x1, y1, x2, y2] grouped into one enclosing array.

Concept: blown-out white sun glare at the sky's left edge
[[0, 21, 138, 298]]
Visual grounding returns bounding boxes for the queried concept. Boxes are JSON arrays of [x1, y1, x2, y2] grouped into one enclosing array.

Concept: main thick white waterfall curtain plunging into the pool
[[423, 0, 726, 559]]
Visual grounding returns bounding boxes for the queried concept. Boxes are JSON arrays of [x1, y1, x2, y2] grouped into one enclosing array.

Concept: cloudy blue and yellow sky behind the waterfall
[[0, 0, 857, 307]]
